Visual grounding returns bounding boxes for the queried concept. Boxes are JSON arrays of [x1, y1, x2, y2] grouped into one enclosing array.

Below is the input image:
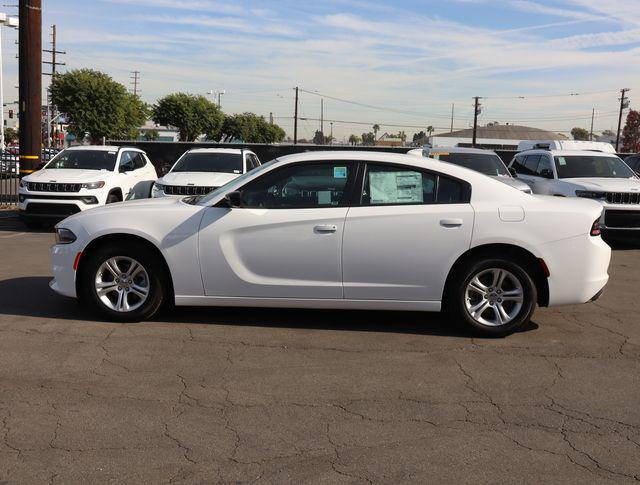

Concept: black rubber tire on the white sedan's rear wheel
[[445, 256, 538, 337]]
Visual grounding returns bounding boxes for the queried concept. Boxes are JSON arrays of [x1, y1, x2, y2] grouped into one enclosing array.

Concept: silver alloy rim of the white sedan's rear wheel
[[464, 268, 524, 327]]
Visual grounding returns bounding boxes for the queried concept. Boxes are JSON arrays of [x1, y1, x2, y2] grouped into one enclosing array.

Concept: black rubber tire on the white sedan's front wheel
[[79, 243, 169, 322]]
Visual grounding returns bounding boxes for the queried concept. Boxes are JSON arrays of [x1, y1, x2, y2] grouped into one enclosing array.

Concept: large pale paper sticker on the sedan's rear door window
[[369, 172, 424, 204]]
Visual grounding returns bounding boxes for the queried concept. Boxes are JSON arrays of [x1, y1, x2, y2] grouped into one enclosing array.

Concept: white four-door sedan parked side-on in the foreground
[[51, 151, 611, 335]]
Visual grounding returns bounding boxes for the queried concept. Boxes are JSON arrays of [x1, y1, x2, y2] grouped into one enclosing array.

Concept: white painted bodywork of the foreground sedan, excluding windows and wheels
[[51, 151, 611, 311]]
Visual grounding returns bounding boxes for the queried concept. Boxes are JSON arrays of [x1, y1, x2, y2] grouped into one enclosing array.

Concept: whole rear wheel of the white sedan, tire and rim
[[449, 258, 537, 336]]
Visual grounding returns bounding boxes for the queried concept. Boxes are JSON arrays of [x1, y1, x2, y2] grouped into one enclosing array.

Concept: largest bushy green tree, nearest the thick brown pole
[[50, 69, 149, 143]]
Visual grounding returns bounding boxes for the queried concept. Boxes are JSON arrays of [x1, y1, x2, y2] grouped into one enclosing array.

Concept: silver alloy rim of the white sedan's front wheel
[[94, 256, 150, 313]]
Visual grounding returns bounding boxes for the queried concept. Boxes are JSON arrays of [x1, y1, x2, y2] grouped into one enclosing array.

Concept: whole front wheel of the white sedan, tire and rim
[[80, 244, 167, 322]]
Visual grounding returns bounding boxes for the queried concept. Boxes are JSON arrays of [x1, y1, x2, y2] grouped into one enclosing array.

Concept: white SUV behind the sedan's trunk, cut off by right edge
[[509, 149, 640, 231]]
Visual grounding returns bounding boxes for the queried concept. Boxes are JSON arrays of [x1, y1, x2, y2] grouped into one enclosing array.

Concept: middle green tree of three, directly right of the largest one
[[152, 93, 224, 141]]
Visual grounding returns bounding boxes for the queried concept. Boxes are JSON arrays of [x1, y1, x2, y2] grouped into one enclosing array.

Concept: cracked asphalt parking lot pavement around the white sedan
[[0, 212, 640, 484]]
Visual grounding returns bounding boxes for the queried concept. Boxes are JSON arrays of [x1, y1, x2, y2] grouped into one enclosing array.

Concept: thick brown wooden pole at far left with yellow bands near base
[[18, 0, 42, 177]]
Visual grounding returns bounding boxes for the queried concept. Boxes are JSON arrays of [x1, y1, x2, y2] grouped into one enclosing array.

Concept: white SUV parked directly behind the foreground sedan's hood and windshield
[[153, 148, 260, 197]]
